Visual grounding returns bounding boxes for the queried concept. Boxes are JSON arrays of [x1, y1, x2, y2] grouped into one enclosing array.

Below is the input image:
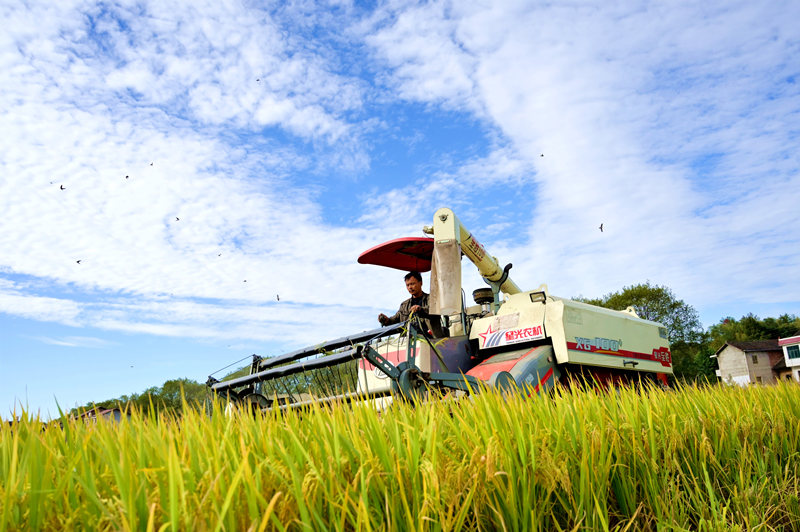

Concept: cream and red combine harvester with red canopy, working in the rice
[[207, 208, 672, 409]]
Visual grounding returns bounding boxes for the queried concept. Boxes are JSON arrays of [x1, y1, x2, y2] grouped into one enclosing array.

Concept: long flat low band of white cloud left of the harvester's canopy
[[0, 277, 394, 348]]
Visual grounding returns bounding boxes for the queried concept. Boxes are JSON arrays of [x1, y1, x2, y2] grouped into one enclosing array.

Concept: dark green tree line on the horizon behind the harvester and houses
[[70, 281, 800, 414]]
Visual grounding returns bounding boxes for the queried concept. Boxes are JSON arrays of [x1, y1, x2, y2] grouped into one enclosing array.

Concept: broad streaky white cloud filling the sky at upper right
[[368, 3, 800, 308]]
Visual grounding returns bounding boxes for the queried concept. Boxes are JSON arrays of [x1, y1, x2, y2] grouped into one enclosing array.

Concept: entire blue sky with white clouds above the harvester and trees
[[0, 0, 800, 418]]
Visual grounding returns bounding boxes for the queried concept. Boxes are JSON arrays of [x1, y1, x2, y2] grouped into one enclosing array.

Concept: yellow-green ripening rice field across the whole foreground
[[0, 383, 800, 532]]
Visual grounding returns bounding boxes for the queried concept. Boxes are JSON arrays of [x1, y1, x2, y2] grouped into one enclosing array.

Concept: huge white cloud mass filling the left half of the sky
[[0, 3, 394, 350]]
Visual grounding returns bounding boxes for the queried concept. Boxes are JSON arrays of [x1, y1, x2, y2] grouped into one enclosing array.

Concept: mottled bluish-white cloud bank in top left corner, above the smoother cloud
[[6, 2, 362, 142]]
